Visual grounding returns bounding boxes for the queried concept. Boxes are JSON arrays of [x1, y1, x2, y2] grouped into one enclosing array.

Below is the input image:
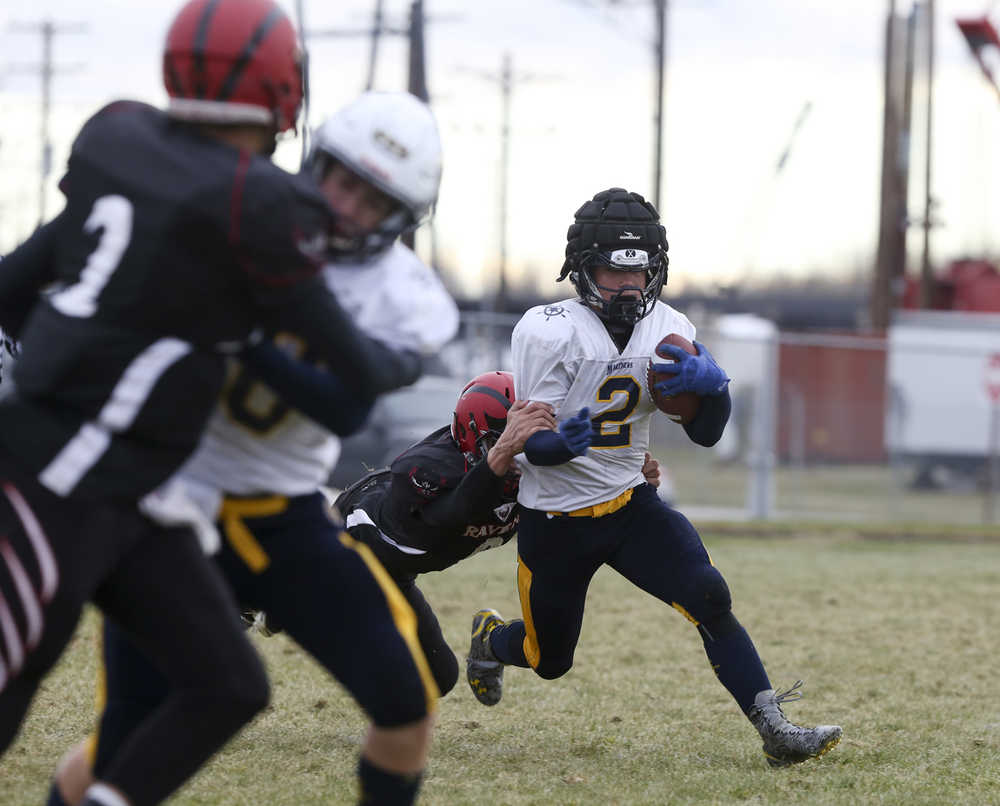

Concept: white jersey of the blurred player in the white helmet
[[181, 241, 458, 506]]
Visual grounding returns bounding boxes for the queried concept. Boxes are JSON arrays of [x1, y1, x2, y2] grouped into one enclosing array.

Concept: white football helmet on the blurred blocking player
[[306, 92, 441, 258]]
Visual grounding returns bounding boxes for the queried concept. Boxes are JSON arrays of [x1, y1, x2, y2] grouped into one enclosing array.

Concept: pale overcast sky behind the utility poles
[[0, 0, 1000, 295]]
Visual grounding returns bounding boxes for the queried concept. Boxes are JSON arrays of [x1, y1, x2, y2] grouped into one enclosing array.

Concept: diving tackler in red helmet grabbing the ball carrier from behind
[[336, 371, 660, 696]]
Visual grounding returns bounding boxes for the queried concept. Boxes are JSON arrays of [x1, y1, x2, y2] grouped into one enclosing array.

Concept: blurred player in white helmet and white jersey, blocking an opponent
[[53, 92, 458, 804]]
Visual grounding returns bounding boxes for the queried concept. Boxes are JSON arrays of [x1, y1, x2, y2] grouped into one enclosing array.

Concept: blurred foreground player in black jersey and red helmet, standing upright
[[0, 0, 419, 806]]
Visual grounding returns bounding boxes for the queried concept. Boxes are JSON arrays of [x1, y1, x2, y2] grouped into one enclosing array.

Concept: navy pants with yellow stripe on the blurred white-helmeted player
[[94, 493, 438, 773]]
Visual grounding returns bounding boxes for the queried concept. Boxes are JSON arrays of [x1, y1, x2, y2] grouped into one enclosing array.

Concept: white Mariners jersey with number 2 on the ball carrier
[[511, 299, 695, 512]]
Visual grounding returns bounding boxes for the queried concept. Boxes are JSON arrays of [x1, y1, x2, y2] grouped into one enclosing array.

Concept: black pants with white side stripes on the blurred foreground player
[[0, 454, 268, 806]]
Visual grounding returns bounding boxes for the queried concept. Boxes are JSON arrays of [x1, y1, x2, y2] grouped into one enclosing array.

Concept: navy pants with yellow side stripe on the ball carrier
[[490, 484, 771, 712]]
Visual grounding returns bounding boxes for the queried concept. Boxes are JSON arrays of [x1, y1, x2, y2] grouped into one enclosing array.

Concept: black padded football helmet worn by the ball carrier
[[557, 188, 669, 328]]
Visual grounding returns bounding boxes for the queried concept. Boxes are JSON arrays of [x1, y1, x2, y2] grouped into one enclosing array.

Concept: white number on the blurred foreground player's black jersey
[[49, 196, 132, 318]]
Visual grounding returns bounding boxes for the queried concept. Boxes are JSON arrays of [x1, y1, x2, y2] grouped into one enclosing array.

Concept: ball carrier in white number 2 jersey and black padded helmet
[[467, 188, 841, 766]]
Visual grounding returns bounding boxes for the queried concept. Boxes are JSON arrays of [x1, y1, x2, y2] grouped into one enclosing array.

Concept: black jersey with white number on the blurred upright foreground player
[[0, 102, 330, 498]]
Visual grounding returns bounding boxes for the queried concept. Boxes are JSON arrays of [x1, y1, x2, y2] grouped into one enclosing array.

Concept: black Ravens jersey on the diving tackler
[[337, 426, 519, 574]]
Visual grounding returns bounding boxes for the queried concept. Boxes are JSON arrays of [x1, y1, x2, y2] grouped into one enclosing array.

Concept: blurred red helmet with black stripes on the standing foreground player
[[163, 0, 302, 132]]
